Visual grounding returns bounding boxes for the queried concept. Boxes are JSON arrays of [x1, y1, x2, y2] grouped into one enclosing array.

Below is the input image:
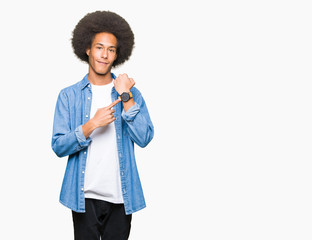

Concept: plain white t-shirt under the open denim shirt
[[84, 82, 123, 203]]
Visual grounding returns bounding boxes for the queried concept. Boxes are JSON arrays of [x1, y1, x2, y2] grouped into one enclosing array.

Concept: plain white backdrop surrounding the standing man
[[0, 0, 312, 240]]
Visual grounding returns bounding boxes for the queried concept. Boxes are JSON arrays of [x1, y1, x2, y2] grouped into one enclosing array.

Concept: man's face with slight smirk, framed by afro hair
[[86, 32, 117, 75]]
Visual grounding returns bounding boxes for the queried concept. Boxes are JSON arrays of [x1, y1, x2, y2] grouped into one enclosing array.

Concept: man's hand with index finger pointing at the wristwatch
[[82, 99, 121, 138]]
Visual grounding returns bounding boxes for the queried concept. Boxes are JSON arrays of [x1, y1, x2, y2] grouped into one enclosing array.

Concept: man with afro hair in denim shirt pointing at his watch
[[52, 11, 154, 240]]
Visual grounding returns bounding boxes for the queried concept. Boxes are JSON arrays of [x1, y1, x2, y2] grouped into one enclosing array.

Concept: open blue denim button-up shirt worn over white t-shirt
[[52, 73, 154, 214]]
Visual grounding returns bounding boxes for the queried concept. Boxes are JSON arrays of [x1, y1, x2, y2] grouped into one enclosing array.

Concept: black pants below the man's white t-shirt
[[72, 198, 132, 240]]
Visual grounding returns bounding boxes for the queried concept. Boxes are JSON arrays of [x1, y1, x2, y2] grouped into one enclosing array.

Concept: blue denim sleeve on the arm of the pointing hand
[[52, 91, 91, 157]]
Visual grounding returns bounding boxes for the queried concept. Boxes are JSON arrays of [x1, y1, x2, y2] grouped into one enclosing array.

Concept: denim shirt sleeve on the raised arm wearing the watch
[[121, 92, 154, 148]]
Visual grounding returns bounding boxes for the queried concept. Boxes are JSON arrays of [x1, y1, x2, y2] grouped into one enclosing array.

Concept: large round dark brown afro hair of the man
[[72, 11, 134, 67]]
